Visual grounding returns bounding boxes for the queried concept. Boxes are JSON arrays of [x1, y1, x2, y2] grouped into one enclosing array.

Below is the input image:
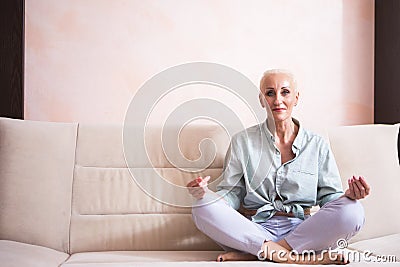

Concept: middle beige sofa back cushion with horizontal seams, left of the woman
[[71, 124, 229, 253]]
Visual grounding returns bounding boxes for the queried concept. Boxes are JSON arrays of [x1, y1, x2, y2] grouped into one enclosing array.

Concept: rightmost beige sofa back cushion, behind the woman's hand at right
[[329, 125, 400, 242]]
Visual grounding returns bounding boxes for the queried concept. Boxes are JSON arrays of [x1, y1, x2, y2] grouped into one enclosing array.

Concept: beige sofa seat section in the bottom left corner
[[0, 240, 69, 267]]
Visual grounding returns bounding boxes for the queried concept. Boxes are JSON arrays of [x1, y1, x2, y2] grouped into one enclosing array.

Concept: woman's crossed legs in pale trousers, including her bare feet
[[192, 197, 364, 264]]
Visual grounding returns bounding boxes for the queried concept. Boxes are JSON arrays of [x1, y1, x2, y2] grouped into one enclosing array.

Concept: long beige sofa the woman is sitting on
[[0, 118, 400, 267]]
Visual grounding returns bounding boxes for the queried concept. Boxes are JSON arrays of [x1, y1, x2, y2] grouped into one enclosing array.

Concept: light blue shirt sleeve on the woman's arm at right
[[317, 141, 343, 207]]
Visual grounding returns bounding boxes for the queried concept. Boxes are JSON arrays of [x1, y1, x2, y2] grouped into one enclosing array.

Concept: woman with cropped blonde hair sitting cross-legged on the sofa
[[187, 70, 370, 264]]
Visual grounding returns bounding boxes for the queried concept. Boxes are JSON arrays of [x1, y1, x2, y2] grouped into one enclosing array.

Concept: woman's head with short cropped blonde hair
[[260, 73, 299, 122]]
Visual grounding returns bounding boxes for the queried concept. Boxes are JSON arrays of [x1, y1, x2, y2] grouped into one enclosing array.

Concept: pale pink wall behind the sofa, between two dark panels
[[25, 0, 374, 132]]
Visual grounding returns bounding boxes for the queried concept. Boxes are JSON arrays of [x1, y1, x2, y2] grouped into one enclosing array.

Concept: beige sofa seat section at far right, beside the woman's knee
[[349, 233, 400, 262]]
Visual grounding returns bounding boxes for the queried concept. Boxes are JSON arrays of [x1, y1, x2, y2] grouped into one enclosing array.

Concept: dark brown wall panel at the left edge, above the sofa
[[0, 0, 24, 119]]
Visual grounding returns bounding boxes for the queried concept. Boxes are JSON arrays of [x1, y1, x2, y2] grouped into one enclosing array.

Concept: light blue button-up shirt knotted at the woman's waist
[[217, 119, 343, 222]]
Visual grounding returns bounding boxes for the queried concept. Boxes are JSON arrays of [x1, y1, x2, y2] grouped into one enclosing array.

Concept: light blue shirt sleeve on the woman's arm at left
[[217, 139, 245, 210]]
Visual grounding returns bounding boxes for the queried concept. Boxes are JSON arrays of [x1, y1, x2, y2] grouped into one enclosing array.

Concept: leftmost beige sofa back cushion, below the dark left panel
[[0, 118, 77, 252]]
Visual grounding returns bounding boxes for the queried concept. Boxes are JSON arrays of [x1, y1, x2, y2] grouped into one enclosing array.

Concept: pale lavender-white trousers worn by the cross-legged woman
[[192, 193, 364, 255]]
